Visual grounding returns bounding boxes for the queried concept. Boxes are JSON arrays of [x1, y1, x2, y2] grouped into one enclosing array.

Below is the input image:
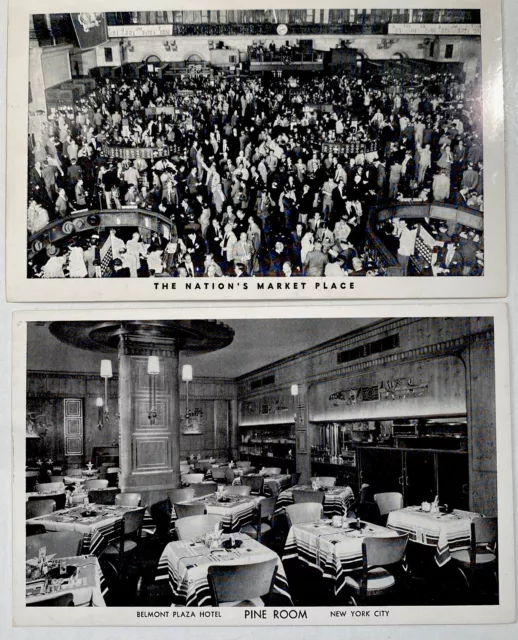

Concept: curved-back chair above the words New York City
[[344, 533, 408, 606]]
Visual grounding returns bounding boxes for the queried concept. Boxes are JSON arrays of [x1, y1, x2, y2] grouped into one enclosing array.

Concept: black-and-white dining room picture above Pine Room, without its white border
[[20, 311, 501, 609]]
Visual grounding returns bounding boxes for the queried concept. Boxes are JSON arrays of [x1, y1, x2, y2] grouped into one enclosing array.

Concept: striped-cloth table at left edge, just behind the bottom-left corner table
[[27, 504, 141, 556]]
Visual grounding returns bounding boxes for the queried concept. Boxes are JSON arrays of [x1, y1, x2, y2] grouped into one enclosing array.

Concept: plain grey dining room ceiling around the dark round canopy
[[27, 318, 377, 378]]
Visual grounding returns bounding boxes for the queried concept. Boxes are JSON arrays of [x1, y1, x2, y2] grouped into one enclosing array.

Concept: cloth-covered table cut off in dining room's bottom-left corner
[[25, 555, 108, 607]]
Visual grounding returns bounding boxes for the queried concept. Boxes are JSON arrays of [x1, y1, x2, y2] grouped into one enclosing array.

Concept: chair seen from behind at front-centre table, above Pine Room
[[208, 558, 277, 607]]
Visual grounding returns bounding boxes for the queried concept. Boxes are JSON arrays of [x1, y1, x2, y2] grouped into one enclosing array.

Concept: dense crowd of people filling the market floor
[[28, 58, 483, 277]]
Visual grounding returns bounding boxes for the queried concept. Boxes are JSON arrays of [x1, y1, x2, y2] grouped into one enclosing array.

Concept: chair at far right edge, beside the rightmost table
[[451, 516, 498, 587]]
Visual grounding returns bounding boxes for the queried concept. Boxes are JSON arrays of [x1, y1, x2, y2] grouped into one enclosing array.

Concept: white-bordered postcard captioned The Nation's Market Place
[[7, 0, 507, 302]]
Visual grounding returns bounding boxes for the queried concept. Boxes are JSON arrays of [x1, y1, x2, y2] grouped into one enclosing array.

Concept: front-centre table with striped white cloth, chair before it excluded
[[155, 533, 293, 607]]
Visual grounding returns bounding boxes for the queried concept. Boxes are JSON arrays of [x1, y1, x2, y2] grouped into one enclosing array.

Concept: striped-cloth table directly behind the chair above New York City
[[282, 518, 398, 595]]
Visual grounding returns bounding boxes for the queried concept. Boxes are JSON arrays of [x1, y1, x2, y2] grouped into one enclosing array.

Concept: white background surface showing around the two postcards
[[0, 0, 518, 640]]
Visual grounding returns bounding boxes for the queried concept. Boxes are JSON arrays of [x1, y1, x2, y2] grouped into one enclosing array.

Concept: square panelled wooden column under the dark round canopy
[[119, 334, 180, 504]]
